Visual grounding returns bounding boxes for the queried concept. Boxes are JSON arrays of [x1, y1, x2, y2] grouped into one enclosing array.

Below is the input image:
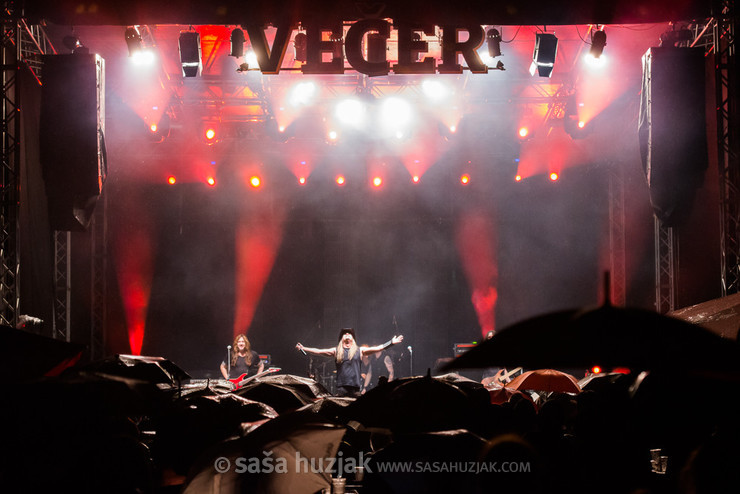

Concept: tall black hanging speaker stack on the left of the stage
[[39, 54, 106, 231]]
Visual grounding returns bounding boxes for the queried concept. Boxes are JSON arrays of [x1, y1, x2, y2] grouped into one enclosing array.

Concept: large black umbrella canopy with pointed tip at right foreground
[[443, 304, 740, 376]]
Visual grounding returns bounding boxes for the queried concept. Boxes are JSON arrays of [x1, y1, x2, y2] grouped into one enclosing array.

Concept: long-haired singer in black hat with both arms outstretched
[[295, 328, 403, 397]]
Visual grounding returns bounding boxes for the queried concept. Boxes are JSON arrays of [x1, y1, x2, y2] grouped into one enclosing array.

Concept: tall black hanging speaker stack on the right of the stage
[[638, 46, 708, 226]]
